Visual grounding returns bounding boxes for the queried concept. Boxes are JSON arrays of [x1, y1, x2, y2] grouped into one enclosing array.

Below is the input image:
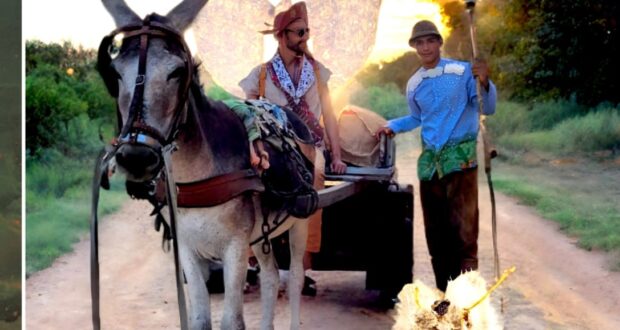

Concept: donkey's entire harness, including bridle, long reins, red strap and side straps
[[95, 14, 318, 329]]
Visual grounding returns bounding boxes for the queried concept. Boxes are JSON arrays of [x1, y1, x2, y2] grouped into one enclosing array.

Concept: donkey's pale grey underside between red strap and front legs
[[178, 197, 254, 260]]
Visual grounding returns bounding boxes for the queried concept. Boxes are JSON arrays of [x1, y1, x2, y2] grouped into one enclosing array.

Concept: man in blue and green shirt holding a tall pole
[[377, 21, 496, 291]]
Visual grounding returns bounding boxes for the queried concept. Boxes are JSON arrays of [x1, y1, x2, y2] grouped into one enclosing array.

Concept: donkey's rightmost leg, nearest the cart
[[288, 219, 308, 330]]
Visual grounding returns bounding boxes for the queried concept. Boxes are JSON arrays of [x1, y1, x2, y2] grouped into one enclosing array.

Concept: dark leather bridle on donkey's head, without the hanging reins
[[97, 15, 194, 154]]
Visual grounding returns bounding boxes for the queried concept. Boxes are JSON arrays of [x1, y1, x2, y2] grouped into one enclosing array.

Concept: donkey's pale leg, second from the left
[[222, 240, 248, 330]]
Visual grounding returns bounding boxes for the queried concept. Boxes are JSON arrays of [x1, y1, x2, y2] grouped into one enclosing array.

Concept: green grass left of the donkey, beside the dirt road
[[25, 116, 126, 274]]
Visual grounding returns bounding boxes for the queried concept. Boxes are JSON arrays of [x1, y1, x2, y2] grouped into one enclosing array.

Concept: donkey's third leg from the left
[[252, 242, 279, 330]]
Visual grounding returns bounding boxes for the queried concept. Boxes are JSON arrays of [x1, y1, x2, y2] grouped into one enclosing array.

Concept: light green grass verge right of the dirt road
[[493, 153, 620, 271]]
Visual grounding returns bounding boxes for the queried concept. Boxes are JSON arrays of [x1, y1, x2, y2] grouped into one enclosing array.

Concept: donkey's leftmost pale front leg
[[179, 246, 211, 330]]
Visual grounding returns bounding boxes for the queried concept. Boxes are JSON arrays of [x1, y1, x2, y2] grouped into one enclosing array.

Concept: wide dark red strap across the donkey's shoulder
[[177, 169, 265, 207]]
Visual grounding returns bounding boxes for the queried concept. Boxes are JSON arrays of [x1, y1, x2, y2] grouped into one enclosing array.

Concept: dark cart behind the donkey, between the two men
[[272, 136, 413, 301]]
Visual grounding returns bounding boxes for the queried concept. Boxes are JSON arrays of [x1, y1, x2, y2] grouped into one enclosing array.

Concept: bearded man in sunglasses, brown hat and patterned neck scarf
[[239, 2, 346, 296]]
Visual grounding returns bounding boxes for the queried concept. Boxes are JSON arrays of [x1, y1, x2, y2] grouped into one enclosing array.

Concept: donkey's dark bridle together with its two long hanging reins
[[90, 15, 194, 330]]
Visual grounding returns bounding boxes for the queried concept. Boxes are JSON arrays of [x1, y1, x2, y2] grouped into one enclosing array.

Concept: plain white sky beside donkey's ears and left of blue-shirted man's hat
[[23, 0, 447, 62]]
